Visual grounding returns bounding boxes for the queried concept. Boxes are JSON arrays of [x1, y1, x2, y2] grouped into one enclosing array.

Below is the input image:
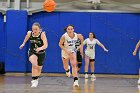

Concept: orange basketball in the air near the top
[[43, 0, 56, 12]]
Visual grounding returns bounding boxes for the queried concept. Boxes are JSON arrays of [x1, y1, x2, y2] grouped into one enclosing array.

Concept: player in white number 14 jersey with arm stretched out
[[84, 32, 108, 80]]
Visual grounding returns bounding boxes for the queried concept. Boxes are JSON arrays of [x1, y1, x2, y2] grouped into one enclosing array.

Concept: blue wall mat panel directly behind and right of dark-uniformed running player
[[28, 12, 60, 72]]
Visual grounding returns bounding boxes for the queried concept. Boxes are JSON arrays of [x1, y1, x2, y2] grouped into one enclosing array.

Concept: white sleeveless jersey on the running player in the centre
[[63, 32, 78, 51]]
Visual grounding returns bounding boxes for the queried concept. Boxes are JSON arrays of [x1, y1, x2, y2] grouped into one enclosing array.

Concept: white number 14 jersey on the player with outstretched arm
[[84, 38, 100, 52]]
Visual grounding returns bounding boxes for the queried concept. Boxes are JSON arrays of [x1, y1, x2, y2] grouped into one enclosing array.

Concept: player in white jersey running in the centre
[[59, 25, 83, 86]]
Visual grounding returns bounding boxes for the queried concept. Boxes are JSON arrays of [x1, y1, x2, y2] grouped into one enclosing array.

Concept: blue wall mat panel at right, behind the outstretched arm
[[91, 13, 140, 74]]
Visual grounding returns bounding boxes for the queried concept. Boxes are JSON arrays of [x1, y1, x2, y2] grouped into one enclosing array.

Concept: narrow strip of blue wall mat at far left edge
[[0, 13, 6, 62]]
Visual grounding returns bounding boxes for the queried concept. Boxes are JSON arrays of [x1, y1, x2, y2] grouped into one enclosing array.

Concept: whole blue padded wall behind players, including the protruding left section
[[4, 11, 140, 74]]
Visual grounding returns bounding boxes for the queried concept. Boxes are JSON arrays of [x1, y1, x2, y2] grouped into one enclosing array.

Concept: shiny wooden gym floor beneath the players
[[0, 73, 140, 93]]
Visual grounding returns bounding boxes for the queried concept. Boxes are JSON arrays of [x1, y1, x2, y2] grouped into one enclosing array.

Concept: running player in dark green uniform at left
[[19, 23, 48, 87]]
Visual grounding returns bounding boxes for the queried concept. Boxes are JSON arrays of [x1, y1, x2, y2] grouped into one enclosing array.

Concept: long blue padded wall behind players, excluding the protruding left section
[[26, 12, 140, 74]]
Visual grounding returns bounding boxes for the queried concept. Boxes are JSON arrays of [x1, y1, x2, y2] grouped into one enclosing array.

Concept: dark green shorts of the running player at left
[[28, 50, 46, 66]]
